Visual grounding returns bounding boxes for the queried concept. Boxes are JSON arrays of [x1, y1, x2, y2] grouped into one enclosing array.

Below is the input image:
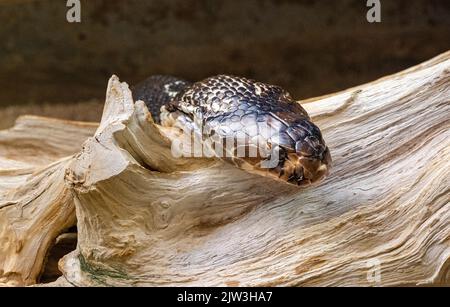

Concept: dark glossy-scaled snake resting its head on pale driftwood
[[131, 75, 332, 187]]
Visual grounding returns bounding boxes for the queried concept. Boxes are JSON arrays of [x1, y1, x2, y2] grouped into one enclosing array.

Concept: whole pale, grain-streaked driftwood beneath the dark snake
[[0, 52, 450, 286]]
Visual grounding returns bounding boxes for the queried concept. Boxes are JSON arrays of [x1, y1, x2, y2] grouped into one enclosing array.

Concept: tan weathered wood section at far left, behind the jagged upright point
[[0, 116, 98, 285]]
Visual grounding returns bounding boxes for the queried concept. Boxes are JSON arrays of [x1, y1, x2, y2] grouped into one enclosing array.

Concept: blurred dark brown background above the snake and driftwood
[[0, 0, 450, 128]]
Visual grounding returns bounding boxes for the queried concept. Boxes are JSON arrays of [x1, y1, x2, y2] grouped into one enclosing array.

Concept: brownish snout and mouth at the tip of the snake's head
[[274, 147, 331, 186]]
